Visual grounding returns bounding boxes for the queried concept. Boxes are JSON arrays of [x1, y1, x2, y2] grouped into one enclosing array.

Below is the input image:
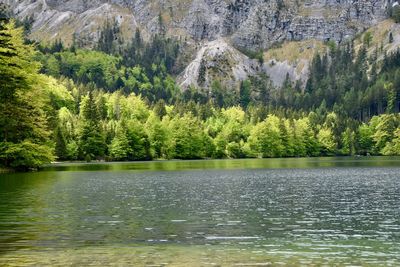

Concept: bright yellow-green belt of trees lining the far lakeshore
[[31, 75, 400, 163]]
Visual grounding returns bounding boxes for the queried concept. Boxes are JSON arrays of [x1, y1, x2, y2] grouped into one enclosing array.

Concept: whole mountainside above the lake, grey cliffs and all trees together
[[0, 0, 400, 170]]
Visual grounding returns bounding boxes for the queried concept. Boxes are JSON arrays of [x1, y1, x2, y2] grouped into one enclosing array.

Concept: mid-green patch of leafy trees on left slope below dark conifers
[[37, 48, 179, 102]]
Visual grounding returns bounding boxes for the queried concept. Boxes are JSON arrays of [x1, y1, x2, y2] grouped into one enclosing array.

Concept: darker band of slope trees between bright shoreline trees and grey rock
[[33, 20, 400, 125]]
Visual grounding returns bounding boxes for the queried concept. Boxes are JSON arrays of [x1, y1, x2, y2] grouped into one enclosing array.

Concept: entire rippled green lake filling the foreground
[[0, 158, 400, 266]]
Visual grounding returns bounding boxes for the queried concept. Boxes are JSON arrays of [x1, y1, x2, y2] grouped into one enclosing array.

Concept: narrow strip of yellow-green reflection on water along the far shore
[[0, 156, 400, 174]]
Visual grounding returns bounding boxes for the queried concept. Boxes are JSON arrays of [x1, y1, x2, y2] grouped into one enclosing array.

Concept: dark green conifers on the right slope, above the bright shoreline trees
[[304, 43, 400, 121]]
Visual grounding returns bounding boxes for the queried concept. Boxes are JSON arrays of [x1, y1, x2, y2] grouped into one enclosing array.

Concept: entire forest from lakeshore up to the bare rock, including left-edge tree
[[0, 19, 400, 170]]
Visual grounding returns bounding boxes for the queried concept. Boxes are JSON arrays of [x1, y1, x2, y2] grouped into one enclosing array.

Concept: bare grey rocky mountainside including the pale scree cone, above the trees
[[3, 0, 398, 88]]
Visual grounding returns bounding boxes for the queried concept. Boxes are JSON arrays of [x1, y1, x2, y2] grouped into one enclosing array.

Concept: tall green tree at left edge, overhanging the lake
[[0, 19, 53, 169]]
